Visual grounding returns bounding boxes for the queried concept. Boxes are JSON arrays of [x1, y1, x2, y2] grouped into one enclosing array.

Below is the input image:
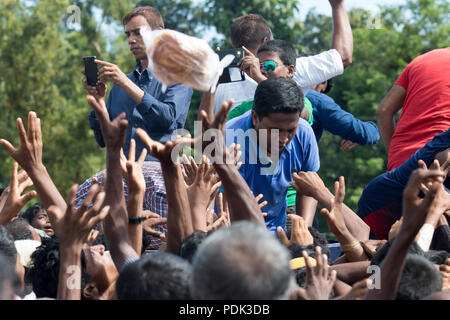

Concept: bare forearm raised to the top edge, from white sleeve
[[329, 0, 353, 68]]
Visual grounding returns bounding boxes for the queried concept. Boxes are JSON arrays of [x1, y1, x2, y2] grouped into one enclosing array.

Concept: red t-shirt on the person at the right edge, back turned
[[388, 47, 450, 171]]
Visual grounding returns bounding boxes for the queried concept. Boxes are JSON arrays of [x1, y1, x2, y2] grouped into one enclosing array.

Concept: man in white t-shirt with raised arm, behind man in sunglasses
[[214, 0, 353, 113]]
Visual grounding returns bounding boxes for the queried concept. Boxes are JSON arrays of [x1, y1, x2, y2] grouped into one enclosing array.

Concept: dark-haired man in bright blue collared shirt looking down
[[225, 78, 320, 232]]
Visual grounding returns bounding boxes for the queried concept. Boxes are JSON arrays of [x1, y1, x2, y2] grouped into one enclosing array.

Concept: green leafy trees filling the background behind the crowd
[[0, 0, 450, 228]]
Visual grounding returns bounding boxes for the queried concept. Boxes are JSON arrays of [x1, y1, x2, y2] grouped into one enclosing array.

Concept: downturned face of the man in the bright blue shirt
[[252, 110, 299, 155]]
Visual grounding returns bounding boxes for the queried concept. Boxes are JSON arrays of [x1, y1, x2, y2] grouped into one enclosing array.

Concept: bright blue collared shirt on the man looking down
[[225, 111, 320, 232]]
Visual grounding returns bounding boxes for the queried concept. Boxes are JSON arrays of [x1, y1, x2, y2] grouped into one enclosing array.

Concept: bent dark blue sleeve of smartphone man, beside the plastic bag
[[136, 84, 193, 131]]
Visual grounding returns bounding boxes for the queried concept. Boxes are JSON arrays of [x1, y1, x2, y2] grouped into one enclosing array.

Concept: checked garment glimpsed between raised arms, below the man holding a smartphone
[[75, 161, 167, 250]]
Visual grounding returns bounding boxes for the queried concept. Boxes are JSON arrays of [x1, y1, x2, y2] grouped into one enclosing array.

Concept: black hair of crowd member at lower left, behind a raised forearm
[[26, 236, 89, 299]]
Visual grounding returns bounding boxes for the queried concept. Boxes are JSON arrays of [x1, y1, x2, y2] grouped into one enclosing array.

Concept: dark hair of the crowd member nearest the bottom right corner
[[396, 254, 442, 300]]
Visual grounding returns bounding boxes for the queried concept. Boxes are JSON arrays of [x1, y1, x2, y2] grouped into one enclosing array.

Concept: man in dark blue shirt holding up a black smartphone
[[83, 7, 193, 161]]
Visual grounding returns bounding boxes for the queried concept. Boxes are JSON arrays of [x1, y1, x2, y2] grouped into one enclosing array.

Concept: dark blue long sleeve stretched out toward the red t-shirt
[[306, 90, 380, 145]]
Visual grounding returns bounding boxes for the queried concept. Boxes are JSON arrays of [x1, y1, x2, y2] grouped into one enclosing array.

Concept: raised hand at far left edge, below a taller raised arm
[[0, 162, 36, 226]]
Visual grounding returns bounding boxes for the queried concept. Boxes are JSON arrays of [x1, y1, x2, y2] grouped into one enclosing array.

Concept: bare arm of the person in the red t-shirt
[[377, 84, 406, 152]]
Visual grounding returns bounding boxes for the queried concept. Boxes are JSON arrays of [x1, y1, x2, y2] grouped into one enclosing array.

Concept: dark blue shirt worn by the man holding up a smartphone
[[89, 62, 193, 161]]
